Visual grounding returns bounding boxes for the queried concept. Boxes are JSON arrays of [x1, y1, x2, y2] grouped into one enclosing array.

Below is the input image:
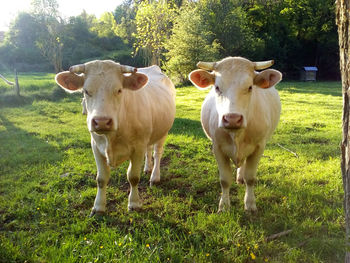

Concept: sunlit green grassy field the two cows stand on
[[0, 74, 345, 263]]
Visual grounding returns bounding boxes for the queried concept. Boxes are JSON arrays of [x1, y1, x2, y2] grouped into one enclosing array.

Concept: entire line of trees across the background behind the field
[[0, 0, 339, 82]]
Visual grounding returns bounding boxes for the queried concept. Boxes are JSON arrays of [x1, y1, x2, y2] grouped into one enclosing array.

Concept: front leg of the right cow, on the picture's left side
[[214, 146, 233, 212]]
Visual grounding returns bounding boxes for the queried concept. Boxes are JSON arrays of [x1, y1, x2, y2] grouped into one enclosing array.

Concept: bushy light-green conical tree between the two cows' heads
[[165, 4, 220, 83]]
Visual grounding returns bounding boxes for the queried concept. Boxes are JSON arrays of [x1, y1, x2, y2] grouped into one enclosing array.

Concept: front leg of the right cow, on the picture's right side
[[242, 147, 264, 212]]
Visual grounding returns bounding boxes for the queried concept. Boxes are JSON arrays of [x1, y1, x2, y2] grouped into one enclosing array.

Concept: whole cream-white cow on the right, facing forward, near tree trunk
[[189, 57, 282, 211]]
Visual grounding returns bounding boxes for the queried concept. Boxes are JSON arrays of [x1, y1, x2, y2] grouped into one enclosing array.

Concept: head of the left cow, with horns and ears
[[55, 60, 148, 133]]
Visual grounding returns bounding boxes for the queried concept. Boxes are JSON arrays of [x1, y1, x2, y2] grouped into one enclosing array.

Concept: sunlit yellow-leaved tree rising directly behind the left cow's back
[[135, 1, 175, 65]]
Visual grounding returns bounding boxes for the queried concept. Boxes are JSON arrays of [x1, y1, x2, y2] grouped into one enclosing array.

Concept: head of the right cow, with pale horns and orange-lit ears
[[189, 57, 282, 130]]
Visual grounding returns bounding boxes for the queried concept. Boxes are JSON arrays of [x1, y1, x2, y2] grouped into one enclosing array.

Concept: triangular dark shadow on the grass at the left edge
[[0, 114, 63, 173]]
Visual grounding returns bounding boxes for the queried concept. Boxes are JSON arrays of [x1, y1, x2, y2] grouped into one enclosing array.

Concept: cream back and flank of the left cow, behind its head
[[119, 66, 175, 144]]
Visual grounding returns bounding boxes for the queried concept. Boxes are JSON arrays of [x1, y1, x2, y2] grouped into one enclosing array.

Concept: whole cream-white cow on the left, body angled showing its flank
[[56, 60, 175, 215]]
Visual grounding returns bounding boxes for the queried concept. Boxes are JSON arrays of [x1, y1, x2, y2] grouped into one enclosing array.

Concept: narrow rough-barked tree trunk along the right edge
[[336, 0, 350, 263]]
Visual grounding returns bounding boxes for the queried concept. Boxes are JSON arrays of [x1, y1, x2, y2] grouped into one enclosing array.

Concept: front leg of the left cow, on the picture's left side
[[90, 144, 110, 216]]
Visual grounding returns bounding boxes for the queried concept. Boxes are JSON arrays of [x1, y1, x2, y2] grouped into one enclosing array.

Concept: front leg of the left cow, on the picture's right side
[[128, 152, 144, 211]]
